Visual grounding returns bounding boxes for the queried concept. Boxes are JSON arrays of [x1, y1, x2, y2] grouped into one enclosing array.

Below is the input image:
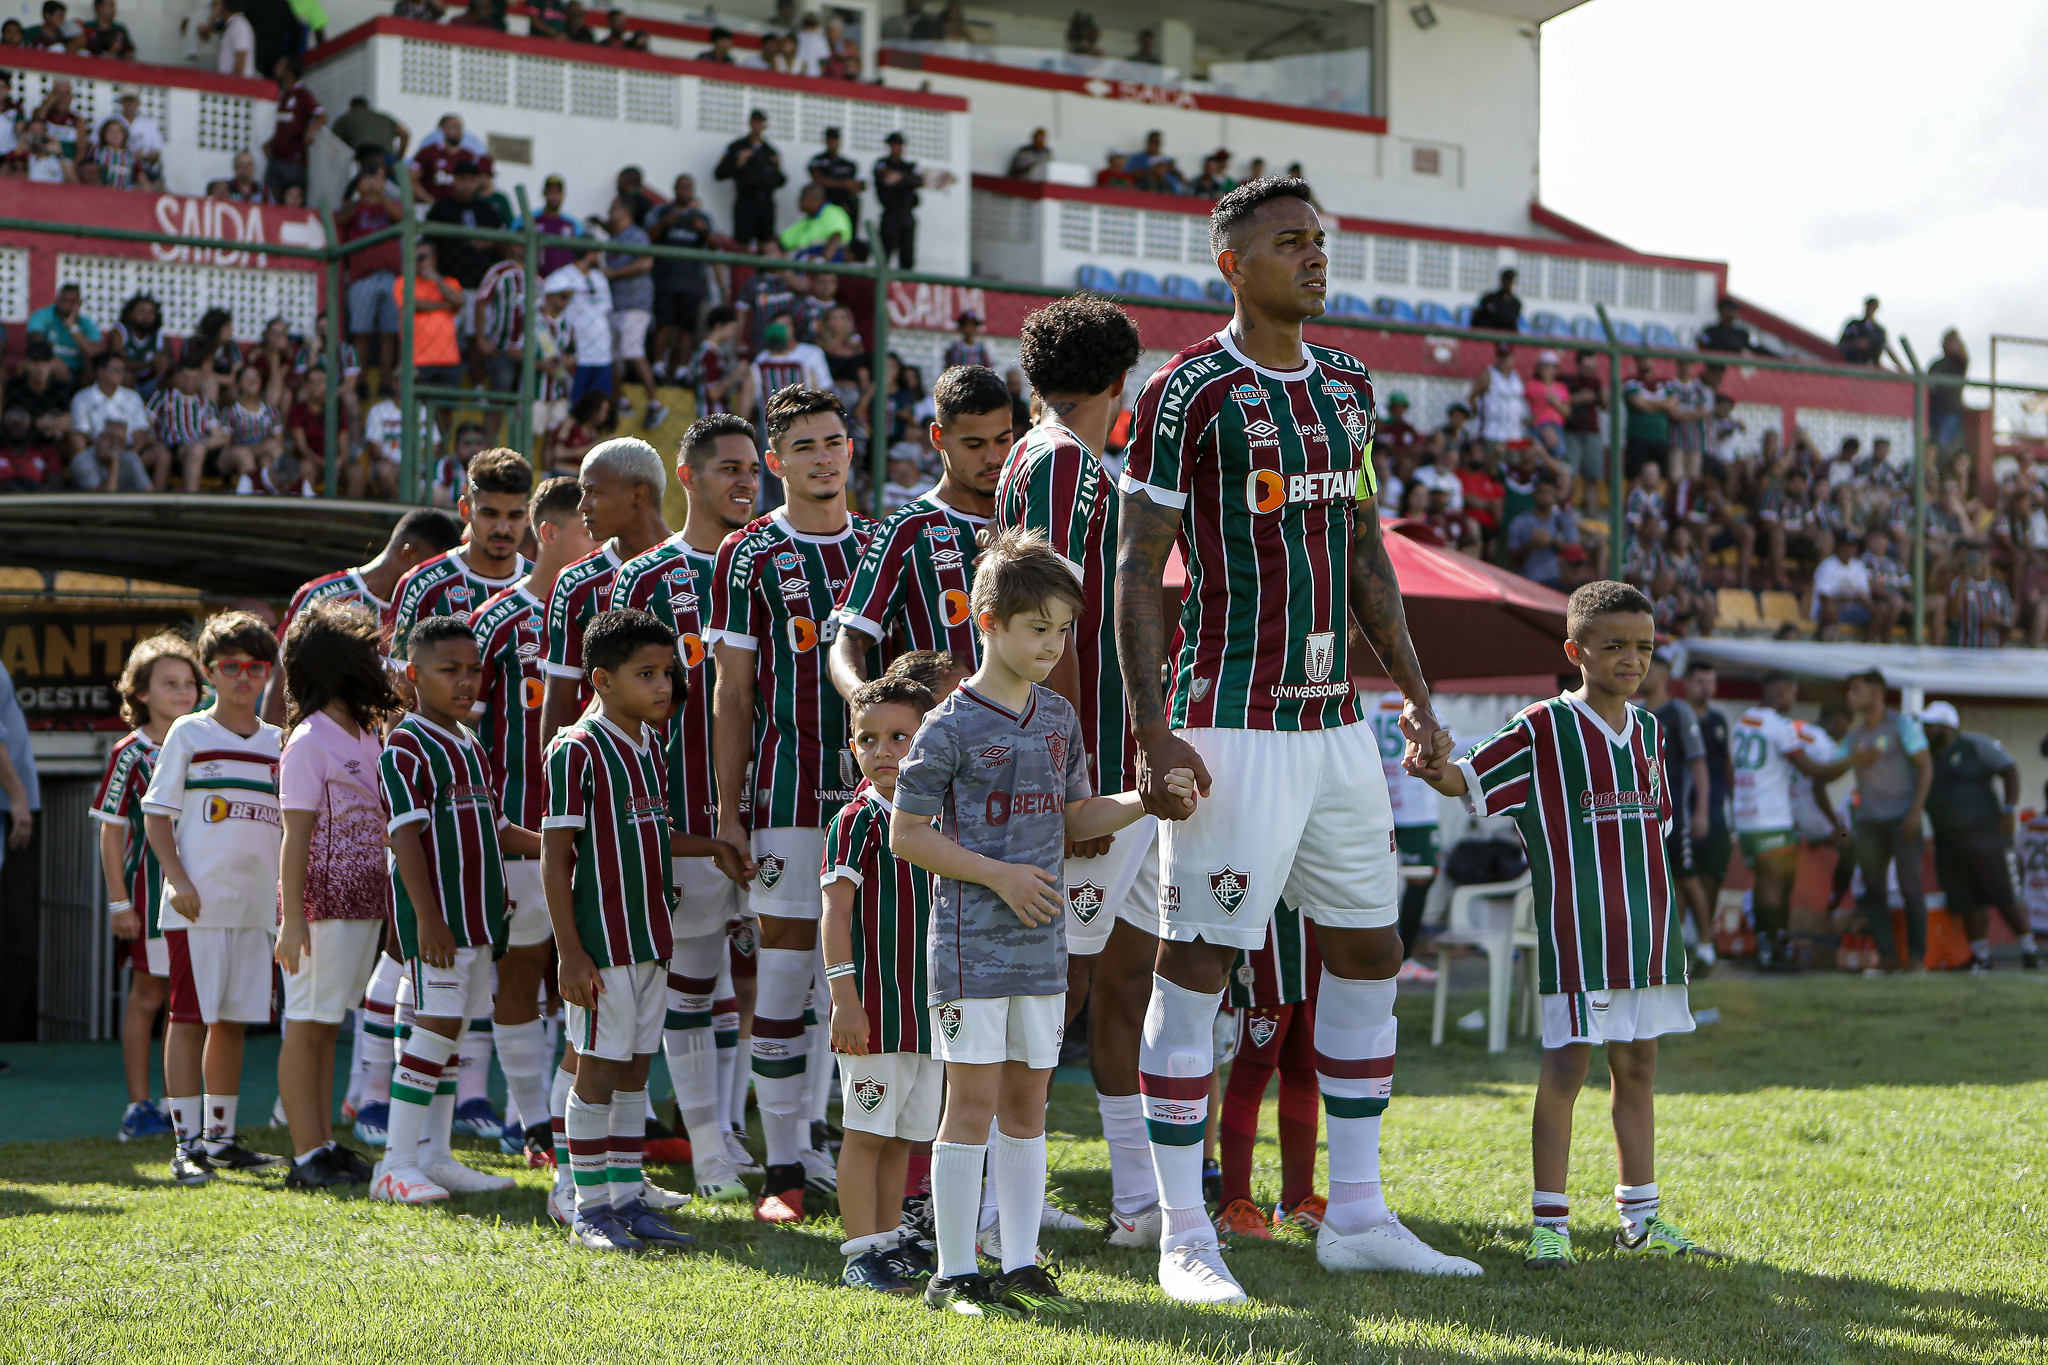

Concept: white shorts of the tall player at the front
[[1159, 724, 1401, 950]]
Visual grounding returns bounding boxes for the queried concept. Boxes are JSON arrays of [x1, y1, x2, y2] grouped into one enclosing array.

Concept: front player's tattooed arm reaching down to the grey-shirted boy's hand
[[1116, 493, 1208, 821]]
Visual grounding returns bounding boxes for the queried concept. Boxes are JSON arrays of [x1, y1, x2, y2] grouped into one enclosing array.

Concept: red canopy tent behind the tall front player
[[1165, 520, 1567, 692]]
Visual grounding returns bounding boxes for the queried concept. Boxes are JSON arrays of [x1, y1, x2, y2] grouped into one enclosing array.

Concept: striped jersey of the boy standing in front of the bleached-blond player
[[541, 714, 674, 966]]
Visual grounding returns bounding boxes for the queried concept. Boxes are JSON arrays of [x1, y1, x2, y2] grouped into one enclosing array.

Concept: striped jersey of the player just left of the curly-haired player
[[838, 489, 987, 671]]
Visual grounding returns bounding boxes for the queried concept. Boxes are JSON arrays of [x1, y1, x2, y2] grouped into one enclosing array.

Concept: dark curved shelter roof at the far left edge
[[0, 493, 408, 598]]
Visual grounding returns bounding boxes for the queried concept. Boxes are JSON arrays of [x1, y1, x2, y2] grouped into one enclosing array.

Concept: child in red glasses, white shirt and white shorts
[[141, 612, 283, 1185]]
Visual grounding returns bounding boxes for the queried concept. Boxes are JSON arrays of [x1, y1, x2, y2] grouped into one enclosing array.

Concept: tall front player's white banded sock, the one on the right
[[1315, 968, 1401, 1232]]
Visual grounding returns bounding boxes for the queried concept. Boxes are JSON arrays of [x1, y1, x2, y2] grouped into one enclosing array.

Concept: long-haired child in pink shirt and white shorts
[[276, 602, 403, 1189]]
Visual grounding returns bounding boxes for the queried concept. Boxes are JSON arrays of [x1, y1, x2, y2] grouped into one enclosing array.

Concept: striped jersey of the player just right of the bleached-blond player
[[612, 532, 719, 837]]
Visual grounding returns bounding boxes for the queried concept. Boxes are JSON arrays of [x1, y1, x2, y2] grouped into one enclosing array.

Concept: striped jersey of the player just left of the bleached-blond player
[[469, 583, 547, 829]]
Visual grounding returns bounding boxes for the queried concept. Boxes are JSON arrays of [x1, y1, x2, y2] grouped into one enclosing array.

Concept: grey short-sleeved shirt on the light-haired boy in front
[[895, 686, 1094, 1005]]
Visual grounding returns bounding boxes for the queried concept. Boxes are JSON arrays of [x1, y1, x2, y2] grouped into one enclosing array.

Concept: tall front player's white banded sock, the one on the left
[[1139, 974, 1223, 1236]]
